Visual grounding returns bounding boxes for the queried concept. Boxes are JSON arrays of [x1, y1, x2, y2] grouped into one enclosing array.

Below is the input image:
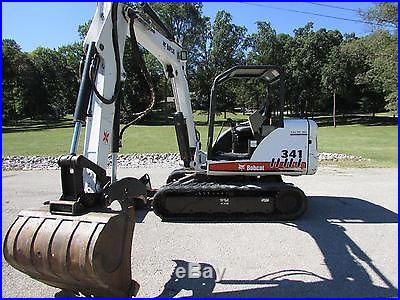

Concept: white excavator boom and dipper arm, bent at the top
[[74, 2, 200, 192]]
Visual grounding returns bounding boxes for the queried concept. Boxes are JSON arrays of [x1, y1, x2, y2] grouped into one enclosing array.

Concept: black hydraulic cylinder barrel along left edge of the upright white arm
[[74, 42, 96, 124]]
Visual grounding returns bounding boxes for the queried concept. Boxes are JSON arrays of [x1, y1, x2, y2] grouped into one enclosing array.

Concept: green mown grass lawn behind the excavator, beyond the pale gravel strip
[[2, 119, 397, 167]]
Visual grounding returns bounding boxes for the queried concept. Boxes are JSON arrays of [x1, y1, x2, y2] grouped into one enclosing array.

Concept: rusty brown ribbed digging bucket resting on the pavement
[[3, 207, 138, 297]]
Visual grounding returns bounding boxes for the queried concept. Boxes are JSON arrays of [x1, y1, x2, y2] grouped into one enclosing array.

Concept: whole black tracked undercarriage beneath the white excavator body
[[153, 173, 307, 221]]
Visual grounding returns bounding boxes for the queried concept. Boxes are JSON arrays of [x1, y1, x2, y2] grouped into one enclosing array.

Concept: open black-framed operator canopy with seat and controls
[[207, 65, 285, 161]]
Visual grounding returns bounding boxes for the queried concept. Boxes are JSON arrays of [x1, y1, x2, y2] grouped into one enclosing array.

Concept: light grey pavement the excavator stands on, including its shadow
[[2, 168, 398, 297]]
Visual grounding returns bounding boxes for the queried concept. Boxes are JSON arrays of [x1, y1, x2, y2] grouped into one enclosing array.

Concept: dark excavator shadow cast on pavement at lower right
[[159, 196, 398, 297]]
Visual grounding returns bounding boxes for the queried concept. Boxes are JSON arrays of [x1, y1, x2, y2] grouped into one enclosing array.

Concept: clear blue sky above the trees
[[2, 2, 372, 51]]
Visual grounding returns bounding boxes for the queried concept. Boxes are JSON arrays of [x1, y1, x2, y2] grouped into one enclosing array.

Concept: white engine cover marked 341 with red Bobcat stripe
[[207, 119, 318, 176]]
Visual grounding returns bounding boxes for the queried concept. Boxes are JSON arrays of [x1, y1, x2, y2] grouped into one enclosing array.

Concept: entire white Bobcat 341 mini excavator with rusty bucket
[[3, 3, 317, 297]]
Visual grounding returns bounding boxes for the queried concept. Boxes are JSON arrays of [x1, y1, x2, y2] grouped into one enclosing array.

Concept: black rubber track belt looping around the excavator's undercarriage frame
[[153, 176, 308, 222]]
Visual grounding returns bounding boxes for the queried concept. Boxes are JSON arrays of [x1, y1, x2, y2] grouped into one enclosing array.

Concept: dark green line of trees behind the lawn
[[2, 2, 398, 123]]
